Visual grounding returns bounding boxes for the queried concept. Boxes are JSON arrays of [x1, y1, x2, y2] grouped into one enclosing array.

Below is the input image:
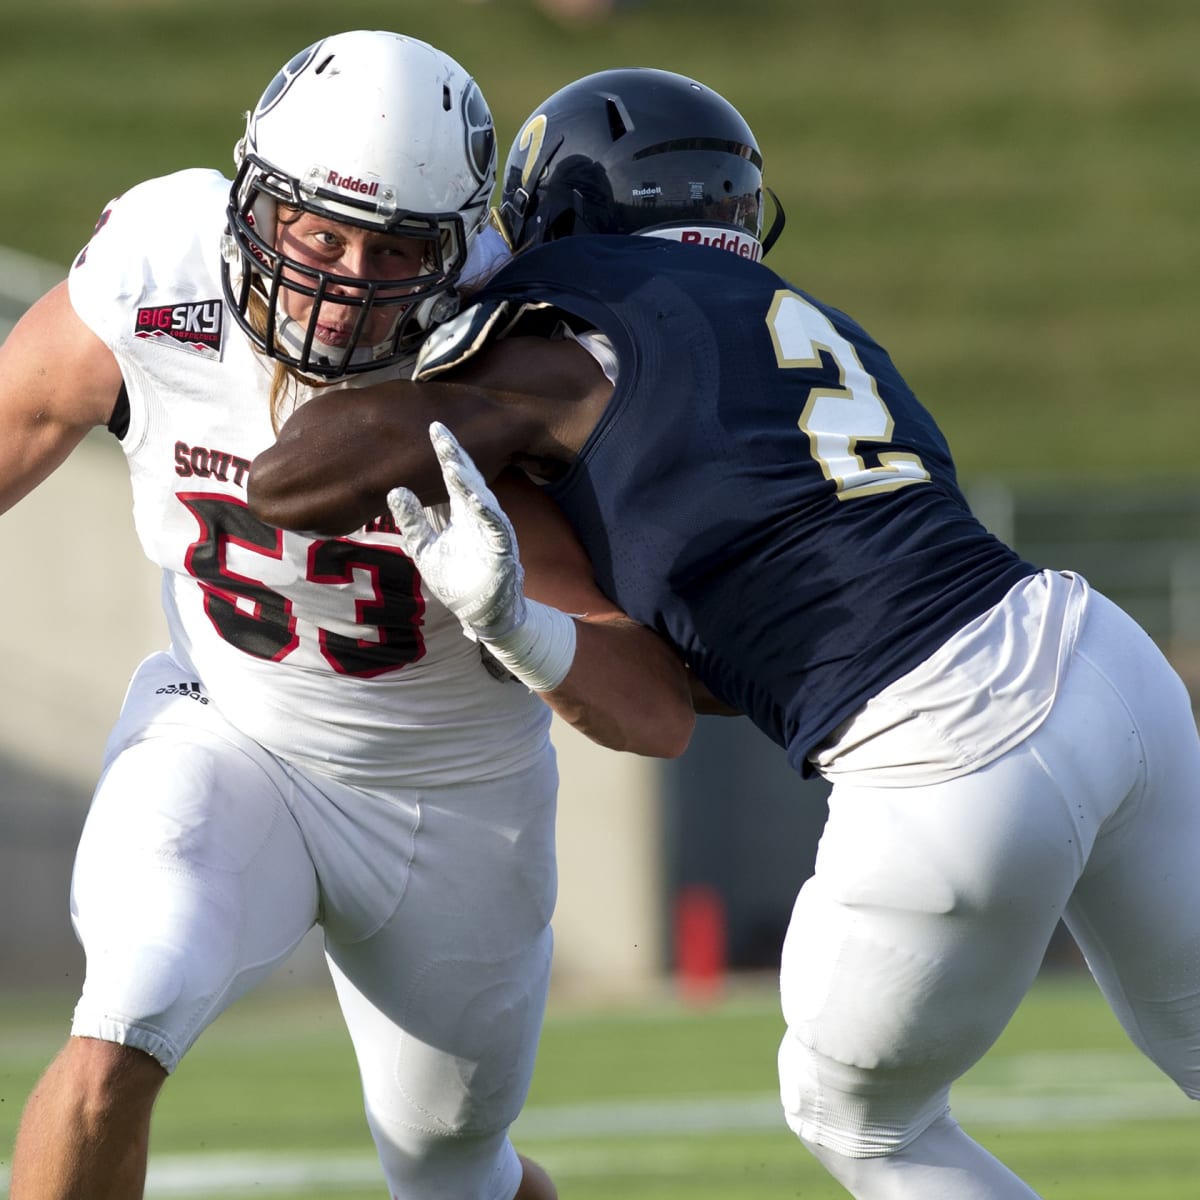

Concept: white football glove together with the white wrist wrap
[[388, 421, 575, 691]]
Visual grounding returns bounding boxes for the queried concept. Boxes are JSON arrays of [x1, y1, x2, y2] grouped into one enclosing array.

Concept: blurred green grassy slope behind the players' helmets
[[0, 0, 1200, 484]]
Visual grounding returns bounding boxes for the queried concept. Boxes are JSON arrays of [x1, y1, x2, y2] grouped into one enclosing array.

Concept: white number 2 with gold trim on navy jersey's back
[[767, 290, 929, 500]]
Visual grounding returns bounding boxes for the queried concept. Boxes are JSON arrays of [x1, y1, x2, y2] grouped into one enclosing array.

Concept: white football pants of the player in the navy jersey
[[779, 593, 1200, 1200]]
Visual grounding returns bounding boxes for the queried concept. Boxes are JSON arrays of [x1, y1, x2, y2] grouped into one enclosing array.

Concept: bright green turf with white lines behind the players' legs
[[0, 974, 1200, 1200]]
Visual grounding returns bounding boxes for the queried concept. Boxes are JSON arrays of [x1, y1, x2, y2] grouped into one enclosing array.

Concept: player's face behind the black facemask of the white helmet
[[275, 209, 427, 347]]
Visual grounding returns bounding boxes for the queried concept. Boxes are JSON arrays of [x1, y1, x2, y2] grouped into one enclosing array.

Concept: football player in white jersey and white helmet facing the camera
[[0, 31, 694, 1200]]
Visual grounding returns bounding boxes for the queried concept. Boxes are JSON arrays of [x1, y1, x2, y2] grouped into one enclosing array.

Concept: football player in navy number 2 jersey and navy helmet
[[250, 70, 1200, 1200]]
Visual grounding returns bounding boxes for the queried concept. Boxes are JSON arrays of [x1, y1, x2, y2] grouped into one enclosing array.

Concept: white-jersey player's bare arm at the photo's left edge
[[0, 282, 121, 511]]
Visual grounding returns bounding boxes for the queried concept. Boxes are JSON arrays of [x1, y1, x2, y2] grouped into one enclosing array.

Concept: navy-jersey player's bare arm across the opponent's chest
[[247, 328, 611, 535]]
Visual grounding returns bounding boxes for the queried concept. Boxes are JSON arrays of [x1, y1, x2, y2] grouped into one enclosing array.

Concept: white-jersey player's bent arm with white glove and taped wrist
[[388, 422, 695, 757]]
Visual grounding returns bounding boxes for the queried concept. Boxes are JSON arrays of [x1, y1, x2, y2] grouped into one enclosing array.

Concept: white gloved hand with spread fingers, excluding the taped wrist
[[388, 421, 526, 641]]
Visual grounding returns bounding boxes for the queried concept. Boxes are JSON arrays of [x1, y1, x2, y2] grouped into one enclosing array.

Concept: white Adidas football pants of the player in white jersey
[[72, 655, 557, 1200]]
